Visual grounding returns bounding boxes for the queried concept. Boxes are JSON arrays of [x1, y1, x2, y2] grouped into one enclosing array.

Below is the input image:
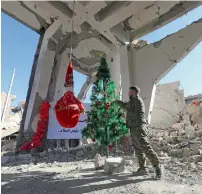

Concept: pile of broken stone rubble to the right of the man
[[149, 101, 202, 169]]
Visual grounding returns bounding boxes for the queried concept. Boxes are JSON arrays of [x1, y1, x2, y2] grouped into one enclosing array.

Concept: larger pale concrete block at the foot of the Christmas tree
[[104, 158, 125, 174]]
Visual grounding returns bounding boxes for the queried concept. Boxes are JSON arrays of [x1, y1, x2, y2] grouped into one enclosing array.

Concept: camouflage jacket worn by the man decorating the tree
[[117, 96, 147, 128]]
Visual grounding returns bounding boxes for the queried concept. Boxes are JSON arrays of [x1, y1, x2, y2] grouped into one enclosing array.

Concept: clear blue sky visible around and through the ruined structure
[[1, 6, 202, 105]]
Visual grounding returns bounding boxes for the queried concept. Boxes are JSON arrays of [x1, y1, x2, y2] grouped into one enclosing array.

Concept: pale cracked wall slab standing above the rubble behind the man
[[150, 81, 185, 129]]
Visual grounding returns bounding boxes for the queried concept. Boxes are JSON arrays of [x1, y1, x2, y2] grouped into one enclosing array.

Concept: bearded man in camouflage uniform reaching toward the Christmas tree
[[115, 86, 162, 179]]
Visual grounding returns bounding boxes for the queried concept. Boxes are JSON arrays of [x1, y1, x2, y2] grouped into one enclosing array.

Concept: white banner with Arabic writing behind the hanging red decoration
[[47, 103, 90, 139]]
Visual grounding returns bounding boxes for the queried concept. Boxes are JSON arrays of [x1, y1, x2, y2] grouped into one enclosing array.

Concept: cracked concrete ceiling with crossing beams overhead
[[1, 1, 201, 74]]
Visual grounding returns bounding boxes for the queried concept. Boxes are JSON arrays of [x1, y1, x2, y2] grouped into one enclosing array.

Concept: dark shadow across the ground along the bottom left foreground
[[1, 171, 152, 194]]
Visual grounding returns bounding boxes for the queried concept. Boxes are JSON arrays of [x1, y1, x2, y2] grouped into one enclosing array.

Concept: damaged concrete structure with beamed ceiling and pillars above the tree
[[2, 1, 202, 151]]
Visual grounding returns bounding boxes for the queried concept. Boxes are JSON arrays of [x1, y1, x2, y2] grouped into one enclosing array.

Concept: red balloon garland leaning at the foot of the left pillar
[[20, 101, 50, 151]]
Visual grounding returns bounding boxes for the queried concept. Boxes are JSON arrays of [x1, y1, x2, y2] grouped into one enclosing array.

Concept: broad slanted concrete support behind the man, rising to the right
[[129, 19, 202, 121]]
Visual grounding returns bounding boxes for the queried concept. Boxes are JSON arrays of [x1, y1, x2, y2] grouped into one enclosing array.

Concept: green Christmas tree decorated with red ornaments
[[82, 57, 128, 155]]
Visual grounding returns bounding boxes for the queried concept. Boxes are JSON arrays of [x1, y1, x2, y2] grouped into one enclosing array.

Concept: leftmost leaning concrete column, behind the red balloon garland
[[24, 20, 61, 135]]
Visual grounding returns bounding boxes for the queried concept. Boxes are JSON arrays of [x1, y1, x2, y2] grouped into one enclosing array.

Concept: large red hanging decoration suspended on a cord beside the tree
[[55, 62, 85, 128]]
